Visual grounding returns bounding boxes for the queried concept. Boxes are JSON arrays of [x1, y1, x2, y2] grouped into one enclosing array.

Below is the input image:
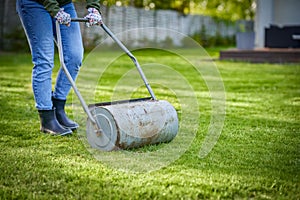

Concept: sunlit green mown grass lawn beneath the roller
[[0, 50, 300, 199]]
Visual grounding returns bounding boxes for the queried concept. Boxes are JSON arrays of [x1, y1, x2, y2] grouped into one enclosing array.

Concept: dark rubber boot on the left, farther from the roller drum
[[39, 109, 72, 136]]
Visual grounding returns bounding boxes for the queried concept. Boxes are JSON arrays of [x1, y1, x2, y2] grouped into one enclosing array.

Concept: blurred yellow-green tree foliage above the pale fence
[[78, 0, 256, 21]]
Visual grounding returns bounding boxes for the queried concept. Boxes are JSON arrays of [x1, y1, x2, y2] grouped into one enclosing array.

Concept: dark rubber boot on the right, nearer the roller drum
[[52, 98, 79, 131]]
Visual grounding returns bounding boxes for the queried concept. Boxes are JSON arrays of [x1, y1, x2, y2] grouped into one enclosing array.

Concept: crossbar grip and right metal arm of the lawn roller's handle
[[71, 18, 157, 100]]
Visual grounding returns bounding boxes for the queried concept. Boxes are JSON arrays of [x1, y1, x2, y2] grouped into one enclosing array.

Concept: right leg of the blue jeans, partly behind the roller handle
[[53, 3, 83, 100]]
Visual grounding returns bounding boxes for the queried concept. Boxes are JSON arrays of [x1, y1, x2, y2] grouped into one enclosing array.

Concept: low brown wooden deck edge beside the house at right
[[220, 48, 300, 63]]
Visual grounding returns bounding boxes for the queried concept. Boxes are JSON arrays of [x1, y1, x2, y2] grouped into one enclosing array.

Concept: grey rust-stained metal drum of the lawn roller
[[87, 100, 178, 151]]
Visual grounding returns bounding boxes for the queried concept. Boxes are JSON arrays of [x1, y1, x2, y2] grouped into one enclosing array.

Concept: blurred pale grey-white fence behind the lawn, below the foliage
[[75, 3, 236, 45]]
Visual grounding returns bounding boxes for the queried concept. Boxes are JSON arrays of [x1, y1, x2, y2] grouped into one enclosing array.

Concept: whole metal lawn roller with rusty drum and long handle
[[56, 18, 178, 151]]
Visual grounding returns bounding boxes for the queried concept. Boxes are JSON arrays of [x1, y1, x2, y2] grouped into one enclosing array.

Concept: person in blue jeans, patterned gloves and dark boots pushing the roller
[[16, 0, 102, 135]]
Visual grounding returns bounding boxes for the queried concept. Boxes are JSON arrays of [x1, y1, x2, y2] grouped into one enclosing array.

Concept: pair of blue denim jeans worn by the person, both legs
[[16, 0, 83, 110]]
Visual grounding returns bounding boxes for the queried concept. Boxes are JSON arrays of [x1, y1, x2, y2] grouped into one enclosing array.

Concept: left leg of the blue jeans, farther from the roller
[[16, 0, 54, 110]]
